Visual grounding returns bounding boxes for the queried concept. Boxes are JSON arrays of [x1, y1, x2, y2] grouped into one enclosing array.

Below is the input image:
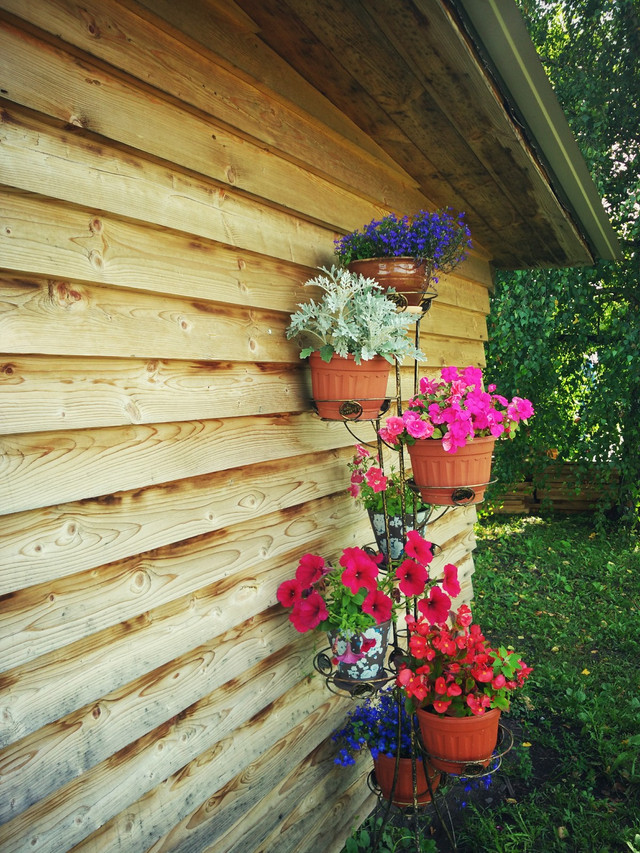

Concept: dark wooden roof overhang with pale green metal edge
[[236, 0, 619, 269]]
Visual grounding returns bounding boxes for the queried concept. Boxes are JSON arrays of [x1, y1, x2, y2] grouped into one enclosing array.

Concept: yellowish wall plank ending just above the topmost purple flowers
[[0, 20, 380, 230]]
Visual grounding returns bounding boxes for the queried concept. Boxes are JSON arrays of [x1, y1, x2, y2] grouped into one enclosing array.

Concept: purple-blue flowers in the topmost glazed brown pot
[[335, 208, 471, 272]]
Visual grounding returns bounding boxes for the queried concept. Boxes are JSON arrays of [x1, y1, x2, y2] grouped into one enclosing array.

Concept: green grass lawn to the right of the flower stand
[[345, 516, 640, 853]]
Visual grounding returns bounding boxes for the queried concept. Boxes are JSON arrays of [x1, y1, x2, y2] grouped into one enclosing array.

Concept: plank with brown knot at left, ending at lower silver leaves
[[0, 272, 299, 362]]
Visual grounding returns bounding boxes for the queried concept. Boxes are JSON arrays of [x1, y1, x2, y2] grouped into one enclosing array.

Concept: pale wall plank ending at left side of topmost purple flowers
[[0, 101, 335, 270]]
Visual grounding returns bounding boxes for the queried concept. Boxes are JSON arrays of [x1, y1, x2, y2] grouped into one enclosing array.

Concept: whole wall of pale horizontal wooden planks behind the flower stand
[[0, 0, 490, 853]]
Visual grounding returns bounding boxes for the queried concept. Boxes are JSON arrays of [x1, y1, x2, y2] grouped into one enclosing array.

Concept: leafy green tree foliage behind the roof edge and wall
[[487, 0, 640, 518]]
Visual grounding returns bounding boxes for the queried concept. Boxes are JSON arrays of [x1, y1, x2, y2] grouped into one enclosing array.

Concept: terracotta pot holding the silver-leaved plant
[[309, 352, 391, 421]]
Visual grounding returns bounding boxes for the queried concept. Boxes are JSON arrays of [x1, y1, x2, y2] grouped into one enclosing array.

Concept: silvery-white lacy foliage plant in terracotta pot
[[287, 266, 425, 364]]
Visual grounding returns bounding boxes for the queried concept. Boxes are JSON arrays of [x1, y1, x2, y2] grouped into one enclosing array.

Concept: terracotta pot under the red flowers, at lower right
[[418, 708, 500, 776]]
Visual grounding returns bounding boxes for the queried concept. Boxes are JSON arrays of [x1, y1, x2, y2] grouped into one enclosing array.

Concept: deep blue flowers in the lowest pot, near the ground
[[332, 689, 418, 767]]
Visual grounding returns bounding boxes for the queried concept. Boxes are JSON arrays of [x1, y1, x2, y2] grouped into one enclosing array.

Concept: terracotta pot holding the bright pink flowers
[[407, 436, 496, 506]]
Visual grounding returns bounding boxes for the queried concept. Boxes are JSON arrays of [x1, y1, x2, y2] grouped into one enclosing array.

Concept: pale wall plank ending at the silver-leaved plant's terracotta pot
[[0, 355, 309, 435]]
